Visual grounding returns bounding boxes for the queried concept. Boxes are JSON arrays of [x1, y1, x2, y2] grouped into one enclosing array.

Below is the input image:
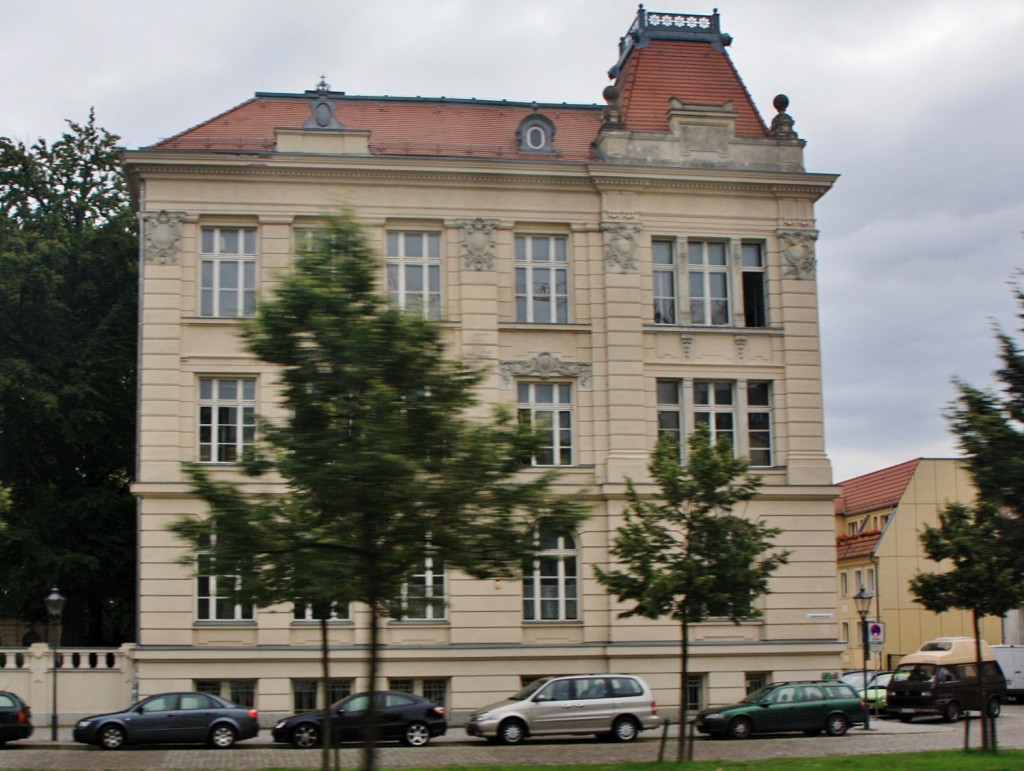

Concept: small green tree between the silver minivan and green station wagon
[[595, 426, 788, 762]]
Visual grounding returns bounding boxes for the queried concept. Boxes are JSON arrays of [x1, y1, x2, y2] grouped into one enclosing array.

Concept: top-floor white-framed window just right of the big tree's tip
[[387, 230, 441, 320]]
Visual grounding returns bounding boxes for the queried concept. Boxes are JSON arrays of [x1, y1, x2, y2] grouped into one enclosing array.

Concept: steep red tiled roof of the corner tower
[[615, 40, 769, 139]]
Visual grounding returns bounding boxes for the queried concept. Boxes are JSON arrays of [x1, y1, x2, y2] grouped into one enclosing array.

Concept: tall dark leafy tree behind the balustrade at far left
[[0, 114, 137, 645]]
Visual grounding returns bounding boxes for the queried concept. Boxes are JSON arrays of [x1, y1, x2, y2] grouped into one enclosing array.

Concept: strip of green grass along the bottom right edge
[[245, 749, 1024, 771]]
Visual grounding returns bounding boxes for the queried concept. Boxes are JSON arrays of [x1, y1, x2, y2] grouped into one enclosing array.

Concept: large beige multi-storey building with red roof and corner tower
[[125, 7, 845, 720]]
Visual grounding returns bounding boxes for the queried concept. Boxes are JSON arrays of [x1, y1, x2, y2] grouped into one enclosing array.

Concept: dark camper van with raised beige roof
[[886, 637, 1007, 723]]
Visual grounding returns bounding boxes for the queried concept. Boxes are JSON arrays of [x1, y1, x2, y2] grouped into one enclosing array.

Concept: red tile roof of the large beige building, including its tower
[[146, 32, 769, 157]]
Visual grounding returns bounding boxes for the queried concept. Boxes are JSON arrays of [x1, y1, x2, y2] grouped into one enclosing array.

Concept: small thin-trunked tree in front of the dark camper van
[[910, 502, 1024, 752]]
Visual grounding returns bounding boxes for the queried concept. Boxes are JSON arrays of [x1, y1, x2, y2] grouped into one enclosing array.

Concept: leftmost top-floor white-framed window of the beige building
[[199, 227, 256, 318]]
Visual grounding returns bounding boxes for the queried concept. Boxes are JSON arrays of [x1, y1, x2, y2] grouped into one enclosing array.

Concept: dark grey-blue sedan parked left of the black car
[[74, 693, 259, 749]]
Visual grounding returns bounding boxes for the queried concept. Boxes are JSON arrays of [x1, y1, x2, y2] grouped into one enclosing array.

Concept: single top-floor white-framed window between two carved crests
[[515, 235, 569, 324]]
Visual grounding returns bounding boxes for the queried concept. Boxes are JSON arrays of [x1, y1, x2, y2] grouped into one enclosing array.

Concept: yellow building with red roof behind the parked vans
[[836, 458, 1002, 669]]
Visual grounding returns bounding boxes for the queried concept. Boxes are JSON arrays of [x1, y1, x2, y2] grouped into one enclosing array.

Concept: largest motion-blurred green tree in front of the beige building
[[174, 210, 583, 769]]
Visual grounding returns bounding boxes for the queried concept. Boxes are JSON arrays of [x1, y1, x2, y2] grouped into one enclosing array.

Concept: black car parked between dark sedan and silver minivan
[[272, 691, 447, 748]]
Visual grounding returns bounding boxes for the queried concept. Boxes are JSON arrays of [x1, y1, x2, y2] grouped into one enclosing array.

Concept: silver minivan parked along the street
[[466, 675, 658, 744]]
